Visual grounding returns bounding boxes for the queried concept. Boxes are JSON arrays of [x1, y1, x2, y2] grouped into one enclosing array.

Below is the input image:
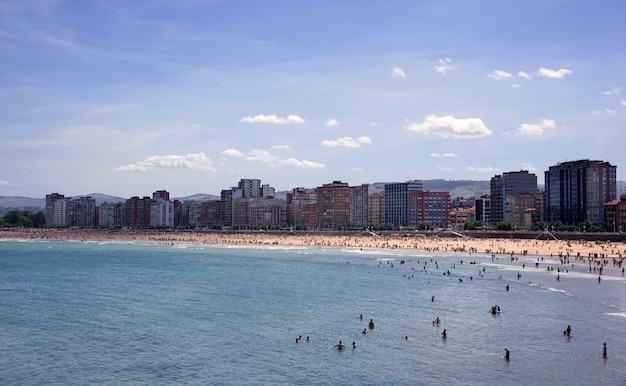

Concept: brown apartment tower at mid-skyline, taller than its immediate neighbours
[[317, 181, 350, 229]]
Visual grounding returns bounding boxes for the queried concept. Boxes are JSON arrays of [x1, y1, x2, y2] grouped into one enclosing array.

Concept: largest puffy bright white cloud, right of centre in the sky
[[407, 114, 492, 138]]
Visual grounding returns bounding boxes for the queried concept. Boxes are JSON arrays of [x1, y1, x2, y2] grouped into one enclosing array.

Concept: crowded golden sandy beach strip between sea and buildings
[[0, 229, 626, 266]]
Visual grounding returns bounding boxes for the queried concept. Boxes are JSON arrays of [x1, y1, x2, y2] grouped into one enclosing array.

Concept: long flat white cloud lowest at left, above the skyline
[[115, 153, 215, 172]]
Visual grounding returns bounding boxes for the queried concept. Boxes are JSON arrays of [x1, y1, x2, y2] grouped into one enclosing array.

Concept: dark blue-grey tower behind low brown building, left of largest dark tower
[[491, 170, 537, 225]]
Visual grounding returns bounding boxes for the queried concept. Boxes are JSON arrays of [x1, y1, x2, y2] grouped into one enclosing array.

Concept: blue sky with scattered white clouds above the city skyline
[[0, 0, 626, 197]]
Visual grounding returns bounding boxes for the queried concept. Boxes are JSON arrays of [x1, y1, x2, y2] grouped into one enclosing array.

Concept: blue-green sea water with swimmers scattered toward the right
[[0, 241, 626, 385]]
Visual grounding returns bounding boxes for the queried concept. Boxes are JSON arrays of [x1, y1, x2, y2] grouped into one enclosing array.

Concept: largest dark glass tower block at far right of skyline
[[544, 160, 617, 225]]
